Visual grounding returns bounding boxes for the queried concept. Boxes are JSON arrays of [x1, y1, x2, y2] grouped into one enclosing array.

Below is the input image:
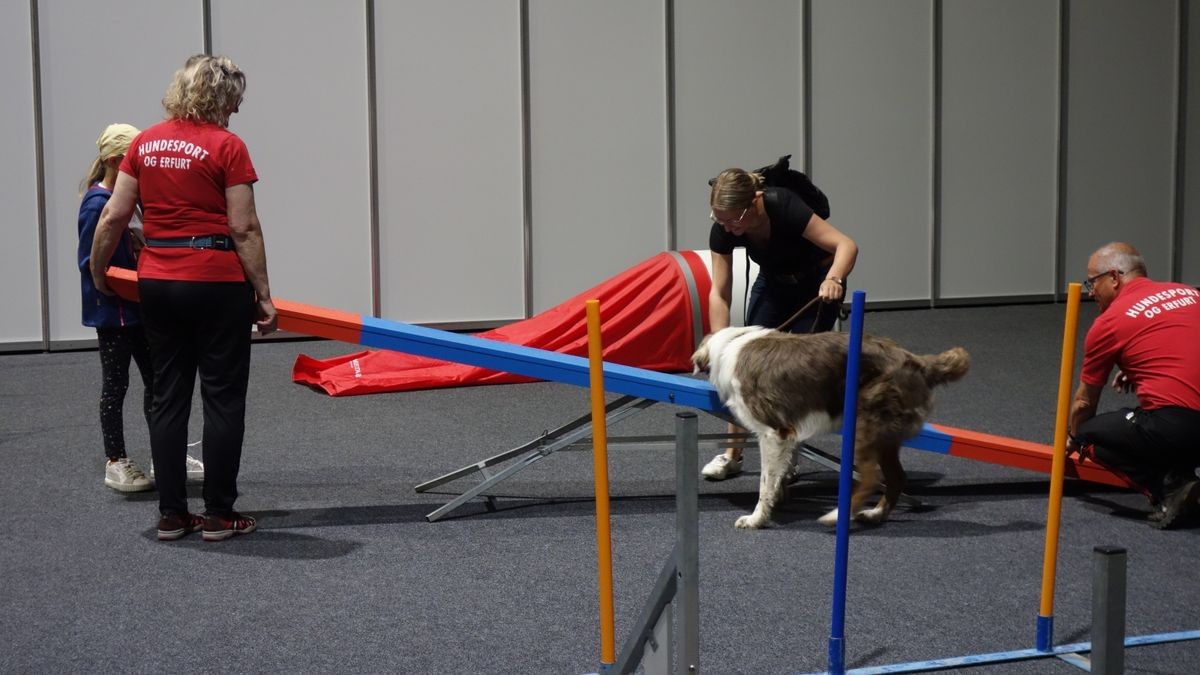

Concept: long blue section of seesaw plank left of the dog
[[361, 317, 725, 412]]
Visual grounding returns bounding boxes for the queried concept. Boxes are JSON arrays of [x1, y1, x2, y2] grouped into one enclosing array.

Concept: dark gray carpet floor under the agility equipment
[[0, 305, 1200, 675]]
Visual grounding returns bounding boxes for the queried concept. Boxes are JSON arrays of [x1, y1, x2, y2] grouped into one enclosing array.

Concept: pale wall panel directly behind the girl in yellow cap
[[38, 0, 204, 340]]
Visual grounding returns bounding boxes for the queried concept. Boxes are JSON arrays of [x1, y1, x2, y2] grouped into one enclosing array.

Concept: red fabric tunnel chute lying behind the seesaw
[[292, 251, 712, 396]]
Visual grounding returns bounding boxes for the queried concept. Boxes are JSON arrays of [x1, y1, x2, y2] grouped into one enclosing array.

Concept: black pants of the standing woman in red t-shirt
[[138, 279, 254, 515]]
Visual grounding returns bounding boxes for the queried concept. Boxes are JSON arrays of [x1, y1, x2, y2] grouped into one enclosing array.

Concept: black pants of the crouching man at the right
[[1076, 407, 1200, 503]]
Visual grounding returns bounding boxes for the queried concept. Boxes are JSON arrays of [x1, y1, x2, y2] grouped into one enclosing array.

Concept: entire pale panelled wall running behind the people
[[11, 0, 1200, 350]]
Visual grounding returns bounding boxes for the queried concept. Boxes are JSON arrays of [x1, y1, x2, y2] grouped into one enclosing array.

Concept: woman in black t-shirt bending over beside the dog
[[702, 168, 858, 480]]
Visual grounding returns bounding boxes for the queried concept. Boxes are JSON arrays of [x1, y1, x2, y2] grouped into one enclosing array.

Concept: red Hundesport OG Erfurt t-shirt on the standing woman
[[121, 120, 258, 281]]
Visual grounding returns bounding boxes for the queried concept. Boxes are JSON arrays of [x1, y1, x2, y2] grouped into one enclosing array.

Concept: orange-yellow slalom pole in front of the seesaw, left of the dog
[[586, 300, 617, 671]]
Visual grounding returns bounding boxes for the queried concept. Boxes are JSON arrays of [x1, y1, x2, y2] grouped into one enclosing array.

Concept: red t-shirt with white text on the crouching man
[[1080, 276, 1200, 411]]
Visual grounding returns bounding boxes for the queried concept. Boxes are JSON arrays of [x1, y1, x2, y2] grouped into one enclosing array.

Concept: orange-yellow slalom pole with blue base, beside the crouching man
[[1037, 283, 1081, 651]]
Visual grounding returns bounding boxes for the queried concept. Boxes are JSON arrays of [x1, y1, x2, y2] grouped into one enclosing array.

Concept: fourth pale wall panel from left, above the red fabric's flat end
[[374, 0, 524, 323]]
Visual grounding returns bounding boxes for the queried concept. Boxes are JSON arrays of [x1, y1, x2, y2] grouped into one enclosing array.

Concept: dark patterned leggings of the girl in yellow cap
[[96, 325, 154, 459]]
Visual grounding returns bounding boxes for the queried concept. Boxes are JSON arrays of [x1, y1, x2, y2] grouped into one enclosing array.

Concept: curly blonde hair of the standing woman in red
[[162, 54, 246, 127]]
